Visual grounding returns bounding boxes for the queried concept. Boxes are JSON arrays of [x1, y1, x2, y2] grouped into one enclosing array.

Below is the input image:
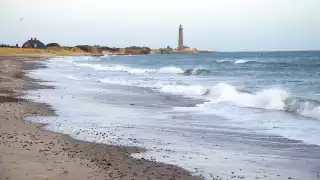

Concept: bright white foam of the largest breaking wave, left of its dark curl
[[160, 83, 289, 110]]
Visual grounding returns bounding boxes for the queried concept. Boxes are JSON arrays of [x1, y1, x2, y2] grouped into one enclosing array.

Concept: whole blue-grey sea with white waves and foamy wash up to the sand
[[25, 51, 320, 180]]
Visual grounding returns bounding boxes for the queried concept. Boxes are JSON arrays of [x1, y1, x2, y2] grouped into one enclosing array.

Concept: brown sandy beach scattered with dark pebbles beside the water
[[0, 56, 199, 180]]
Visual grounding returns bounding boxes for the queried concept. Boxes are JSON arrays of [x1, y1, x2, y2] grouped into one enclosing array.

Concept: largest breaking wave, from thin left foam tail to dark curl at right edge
[[159, 83, 320, 120]]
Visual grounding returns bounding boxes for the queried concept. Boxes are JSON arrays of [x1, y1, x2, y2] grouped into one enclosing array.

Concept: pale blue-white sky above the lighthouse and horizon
[[0, 0, 320, 51]]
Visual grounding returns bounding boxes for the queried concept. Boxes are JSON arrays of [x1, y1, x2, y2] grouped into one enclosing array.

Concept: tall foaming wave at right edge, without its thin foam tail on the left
[[206, 83, 320, 120]]
